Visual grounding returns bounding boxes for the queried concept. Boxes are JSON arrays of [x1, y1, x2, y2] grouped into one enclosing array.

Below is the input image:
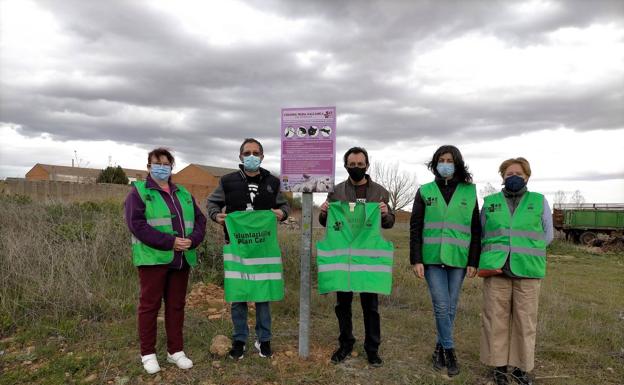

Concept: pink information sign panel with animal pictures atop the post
[[280, 107, 336, 192]]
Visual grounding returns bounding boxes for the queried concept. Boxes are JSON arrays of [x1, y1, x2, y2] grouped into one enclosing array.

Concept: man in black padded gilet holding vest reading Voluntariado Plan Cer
[[207, 138, 289, 360]]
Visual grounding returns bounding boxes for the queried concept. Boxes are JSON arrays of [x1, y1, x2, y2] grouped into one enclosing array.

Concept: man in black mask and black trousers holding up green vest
[[317, 147, 394, 366]]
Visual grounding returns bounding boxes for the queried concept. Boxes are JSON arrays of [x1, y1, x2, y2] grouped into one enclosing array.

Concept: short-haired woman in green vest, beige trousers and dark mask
[[479, 158, 553, 385]]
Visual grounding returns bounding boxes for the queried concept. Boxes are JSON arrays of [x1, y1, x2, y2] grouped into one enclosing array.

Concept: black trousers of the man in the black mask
[[336, 291, 381, 353]]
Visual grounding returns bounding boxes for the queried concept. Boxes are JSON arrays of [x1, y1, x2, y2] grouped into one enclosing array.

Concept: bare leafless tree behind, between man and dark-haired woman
[[371, 162, 419, 210]]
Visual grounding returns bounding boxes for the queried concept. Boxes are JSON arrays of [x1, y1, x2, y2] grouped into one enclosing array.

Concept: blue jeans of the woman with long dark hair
[[425, 265, 466, 349]]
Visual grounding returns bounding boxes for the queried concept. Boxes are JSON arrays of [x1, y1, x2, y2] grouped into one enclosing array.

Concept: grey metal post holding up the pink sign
[[299, 192, 313, 358]]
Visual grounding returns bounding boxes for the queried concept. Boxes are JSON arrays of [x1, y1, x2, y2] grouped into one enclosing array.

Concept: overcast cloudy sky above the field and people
[[0, 0, 624, 202]]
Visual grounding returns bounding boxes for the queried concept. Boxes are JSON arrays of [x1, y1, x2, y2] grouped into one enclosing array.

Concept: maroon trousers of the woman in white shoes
[[137, 265, 190, 356]]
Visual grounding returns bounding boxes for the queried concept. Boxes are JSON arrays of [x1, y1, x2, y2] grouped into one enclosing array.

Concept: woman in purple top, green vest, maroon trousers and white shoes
[[125, 148, 206, 374]]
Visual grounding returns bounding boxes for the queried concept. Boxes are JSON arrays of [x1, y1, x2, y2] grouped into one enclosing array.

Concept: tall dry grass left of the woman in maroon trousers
[[0, 197, 136, 328]]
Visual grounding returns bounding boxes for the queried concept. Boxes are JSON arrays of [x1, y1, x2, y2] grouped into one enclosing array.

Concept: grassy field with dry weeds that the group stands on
[[0, 197, 624, 385]]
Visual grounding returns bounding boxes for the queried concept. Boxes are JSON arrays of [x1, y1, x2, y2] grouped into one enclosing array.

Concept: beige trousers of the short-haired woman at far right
[[480, 275, 541, 372]]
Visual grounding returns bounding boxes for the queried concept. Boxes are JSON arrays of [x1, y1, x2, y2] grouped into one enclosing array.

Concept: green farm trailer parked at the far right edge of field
[[553, 203, 624, 245]]
